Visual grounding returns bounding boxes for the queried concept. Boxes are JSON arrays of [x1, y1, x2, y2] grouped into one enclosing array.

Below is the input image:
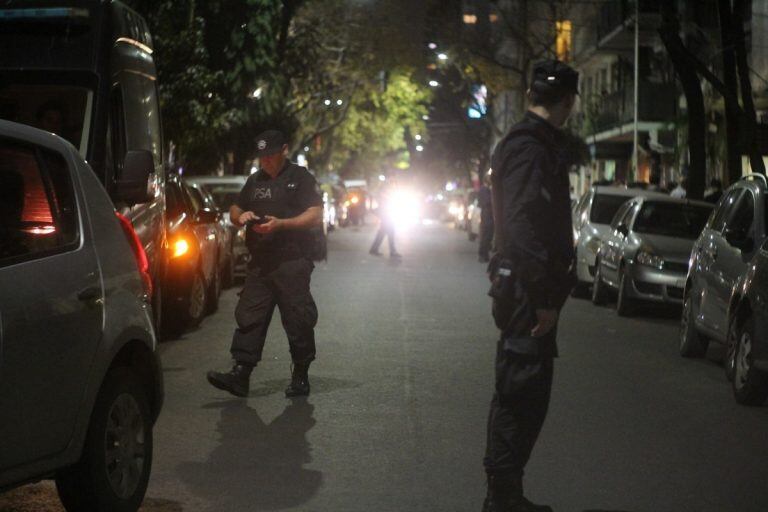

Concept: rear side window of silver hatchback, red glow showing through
[[0, 139, 78, 266]]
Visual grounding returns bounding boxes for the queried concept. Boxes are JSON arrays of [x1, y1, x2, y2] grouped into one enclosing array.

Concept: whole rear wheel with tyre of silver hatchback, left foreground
[[56, 368, 152, 512]]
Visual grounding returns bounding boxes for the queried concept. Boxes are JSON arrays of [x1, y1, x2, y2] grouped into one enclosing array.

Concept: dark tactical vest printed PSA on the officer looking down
[[245, 163, 311, 263]]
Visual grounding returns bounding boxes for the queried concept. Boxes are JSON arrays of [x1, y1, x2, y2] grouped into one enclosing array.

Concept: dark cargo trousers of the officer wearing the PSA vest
[[231, 258, 317, 365]]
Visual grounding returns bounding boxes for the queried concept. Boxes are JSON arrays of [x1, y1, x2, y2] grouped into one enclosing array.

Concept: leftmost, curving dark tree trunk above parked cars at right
[[659, 2, 707, 199]]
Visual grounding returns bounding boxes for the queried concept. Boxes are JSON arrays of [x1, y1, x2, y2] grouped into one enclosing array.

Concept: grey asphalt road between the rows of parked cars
[[0, 222, 768, 512]]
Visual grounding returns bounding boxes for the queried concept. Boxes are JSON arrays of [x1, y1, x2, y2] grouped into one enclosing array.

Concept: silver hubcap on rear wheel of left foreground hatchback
[[105, 393, 146, 499]]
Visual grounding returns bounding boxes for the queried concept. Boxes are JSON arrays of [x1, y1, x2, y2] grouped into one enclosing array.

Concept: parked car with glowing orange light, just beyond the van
[[164, 175, 221, 335]]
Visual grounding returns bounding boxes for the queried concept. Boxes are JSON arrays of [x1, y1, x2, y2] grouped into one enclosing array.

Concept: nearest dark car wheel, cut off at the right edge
[[733, 317, 768, 405]]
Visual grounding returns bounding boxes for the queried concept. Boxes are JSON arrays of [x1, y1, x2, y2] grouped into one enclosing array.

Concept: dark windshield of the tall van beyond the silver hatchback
[[0, 83, 93, 157]]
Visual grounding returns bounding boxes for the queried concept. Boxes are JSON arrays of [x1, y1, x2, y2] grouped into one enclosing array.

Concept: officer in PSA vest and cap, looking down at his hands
[[207, 130, 323, 397]]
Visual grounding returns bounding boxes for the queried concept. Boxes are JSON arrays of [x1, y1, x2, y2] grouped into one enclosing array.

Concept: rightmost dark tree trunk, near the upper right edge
[[732, 0, 765, 174]]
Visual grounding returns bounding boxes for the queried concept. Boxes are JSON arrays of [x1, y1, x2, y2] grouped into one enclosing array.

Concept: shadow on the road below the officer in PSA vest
[[178, 400, 323, 511]]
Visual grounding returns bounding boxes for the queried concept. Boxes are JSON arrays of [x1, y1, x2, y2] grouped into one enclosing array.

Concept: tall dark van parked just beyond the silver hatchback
[[0, 0, 167, 332]]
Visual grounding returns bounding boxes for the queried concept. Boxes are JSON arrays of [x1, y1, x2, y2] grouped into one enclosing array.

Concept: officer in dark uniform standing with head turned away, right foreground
[[483, 60, 578, 512]]
